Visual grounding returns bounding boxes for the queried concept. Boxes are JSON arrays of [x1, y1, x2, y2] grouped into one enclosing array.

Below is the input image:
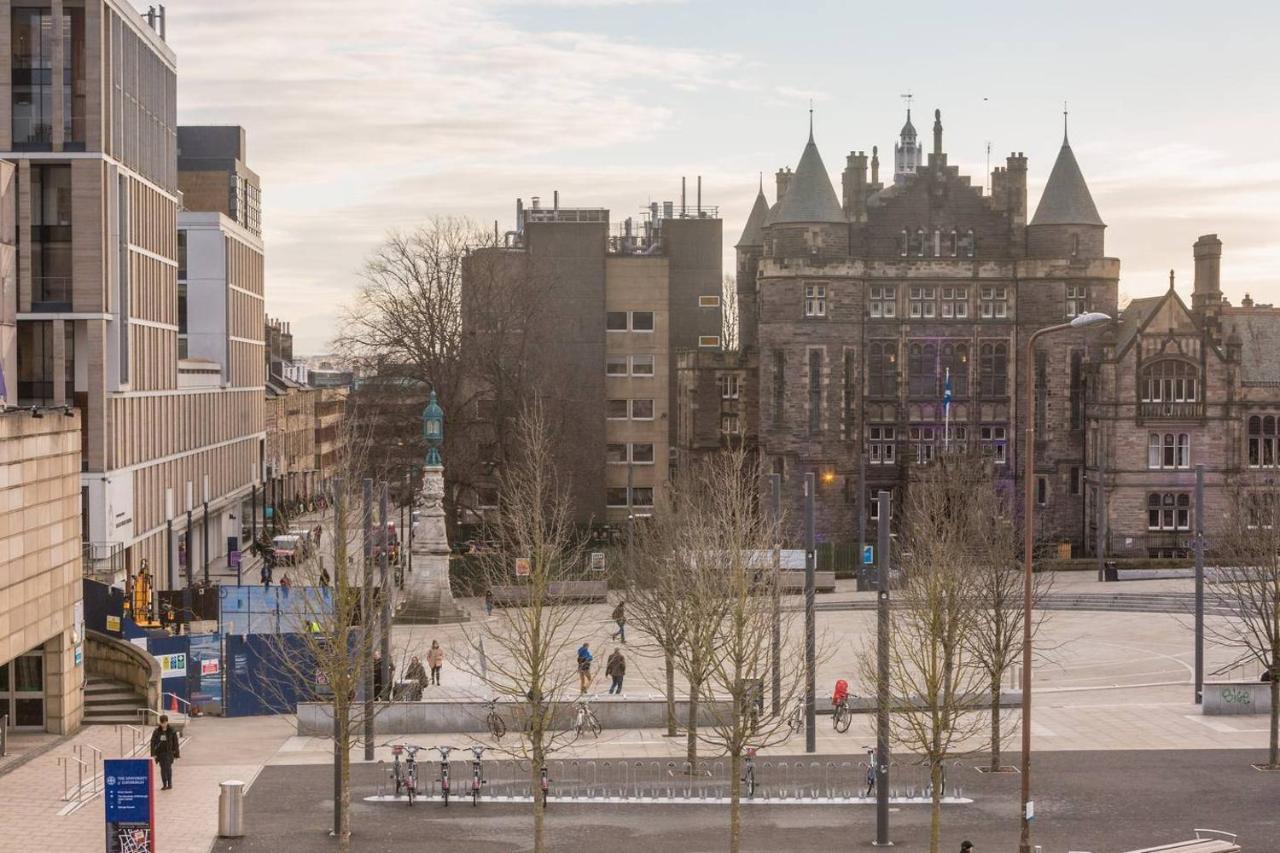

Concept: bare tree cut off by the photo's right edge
[[1206, 485, 1280, 770]]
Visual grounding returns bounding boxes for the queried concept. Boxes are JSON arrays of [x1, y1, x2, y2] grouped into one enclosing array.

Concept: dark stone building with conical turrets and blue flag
[[737, 111, 1120, 543]]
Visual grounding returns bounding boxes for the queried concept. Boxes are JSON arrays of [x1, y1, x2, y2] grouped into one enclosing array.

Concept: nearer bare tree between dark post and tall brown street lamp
[[863, 453, 991, 853]]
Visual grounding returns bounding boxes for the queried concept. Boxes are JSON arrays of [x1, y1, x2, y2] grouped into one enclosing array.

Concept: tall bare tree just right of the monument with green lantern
[[460, 403, 585, 850]]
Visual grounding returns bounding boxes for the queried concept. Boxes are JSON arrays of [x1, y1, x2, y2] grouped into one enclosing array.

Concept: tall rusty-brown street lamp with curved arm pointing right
[[1018, 311, 1111, 853]]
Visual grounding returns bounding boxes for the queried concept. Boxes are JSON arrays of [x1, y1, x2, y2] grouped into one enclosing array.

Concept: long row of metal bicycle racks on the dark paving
[[366, 751, 972, 804]]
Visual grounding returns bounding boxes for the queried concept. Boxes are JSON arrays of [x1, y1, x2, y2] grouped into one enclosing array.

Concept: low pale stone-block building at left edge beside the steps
[[0, 411, 84, 734]]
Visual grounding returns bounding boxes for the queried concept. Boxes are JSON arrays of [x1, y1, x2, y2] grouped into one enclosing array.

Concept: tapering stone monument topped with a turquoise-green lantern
[[396, 391, 470, 625]]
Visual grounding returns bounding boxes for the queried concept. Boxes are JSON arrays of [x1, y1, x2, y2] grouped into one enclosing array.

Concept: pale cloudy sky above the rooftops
[[166, 0, 1280, 355]]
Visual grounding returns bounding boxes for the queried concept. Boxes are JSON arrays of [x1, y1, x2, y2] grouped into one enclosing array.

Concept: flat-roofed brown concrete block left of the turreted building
[[462, 192, 722, 526]]
